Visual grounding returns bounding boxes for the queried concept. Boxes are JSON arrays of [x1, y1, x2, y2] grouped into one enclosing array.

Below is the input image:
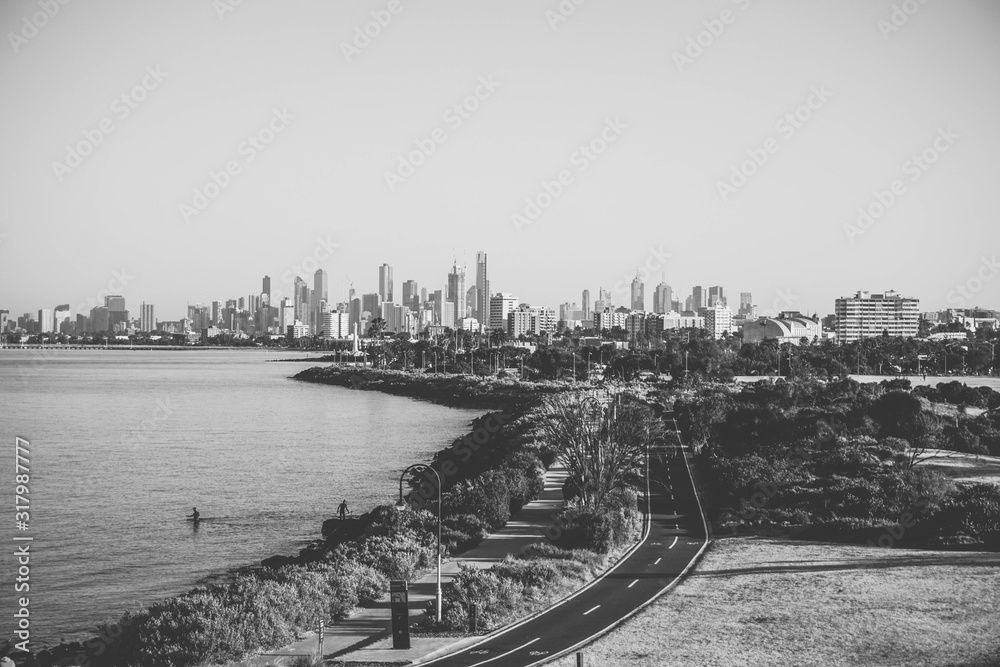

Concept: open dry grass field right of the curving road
[[551, 537, 1000, 667]]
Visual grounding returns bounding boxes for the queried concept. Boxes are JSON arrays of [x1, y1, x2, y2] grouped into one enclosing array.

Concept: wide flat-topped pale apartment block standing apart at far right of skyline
[[834, 291, 920, 343]]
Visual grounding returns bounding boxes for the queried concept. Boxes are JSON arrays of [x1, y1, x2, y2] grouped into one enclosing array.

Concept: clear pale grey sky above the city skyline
[[0, 0, 1000, 319]]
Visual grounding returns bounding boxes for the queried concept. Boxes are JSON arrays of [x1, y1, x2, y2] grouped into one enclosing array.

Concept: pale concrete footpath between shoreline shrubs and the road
[[233, 464, 567, 667]]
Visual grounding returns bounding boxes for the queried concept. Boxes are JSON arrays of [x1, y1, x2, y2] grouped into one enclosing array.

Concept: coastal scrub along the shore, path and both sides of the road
[[31, 366, 1000, 667]]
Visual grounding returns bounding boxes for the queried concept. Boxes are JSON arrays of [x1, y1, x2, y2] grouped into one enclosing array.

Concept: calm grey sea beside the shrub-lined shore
[[0, 349, 482, 648]]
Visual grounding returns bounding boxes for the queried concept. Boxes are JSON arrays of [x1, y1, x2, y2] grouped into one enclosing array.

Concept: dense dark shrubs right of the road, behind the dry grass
[[674, 378, 1000, 549]]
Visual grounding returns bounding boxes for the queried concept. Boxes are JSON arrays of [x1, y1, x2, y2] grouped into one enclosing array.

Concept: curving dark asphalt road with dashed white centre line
[[424, 438, 707, 667]]
